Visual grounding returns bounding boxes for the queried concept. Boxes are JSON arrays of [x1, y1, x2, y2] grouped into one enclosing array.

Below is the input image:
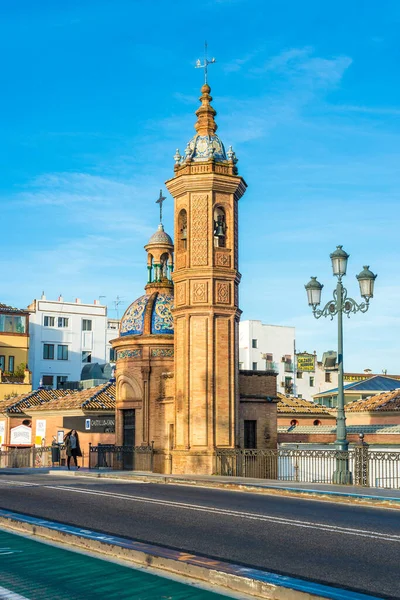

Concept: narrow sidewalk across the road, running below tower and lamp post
[[0, 467, 400, 508]]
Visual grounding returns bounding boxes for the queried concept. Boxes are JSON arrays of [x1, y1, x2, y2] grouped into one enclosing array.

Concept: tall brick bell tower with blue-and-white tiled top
[[166, 83, 247, 474]]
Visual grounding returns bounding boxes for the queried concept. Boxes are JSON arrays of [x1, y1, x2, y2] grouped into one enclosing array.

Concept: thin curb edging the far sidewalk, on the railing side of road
[[74, 471, 400, 508]]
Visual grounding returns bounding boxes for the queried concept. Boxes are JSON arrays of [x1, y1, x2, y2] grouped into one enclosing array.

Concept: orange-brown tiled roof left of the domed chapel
[[0, 381, 115, 414]]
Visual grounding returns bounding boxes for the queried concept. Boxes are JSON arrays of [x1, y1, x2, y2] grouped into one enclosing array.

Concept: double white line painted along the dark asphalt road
[[0, 480, 400, 543]]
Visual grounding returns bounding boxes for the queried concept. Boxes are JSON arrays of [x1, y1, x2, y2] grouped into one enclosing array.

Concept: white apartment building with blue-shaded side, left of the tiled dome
[[28, 294, 119, 389]]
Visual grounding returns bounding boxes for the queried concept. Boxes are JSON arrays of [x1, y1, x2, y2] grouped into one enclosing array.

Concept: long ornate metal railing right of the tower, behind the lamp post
[[215, 444, 400, 488]]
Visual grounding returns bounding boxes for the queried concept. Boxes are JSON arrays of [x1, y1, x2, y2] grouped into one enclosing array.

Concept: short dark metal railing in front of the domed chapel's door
[[89, 444, 154, 471]]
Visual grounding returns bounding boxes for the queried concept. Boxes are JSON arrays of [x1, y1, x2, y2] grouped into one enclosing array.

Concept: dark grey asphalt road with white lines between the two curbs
[[0, 473, 400, 599]]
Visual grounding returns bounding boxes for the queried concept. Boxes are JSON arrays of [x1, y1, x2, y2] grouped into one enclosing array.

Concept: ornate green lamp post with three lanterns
[[305, 246, 376, 484]]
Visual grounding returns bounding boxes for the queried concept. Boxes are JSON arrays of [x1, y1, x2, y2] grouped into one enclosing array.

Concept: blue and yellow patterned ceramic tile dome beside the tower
[[120, 291, 174, 336]]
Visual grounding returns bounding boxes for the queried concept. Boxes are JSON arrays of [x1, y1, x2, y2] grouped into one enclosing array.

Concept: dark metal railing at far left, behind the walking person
[[0, 444, 85, 469]]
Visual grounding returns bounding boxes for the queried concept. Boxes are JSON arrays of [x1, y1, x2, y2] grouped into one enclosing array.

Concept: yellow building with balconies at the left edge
[[0, 304, 32, 400]]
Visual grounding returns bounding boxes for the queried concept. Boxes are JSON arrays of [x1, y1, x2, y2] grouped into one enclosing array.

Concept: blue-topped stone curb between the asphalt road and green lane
[[0, 509, 378, 600]]
